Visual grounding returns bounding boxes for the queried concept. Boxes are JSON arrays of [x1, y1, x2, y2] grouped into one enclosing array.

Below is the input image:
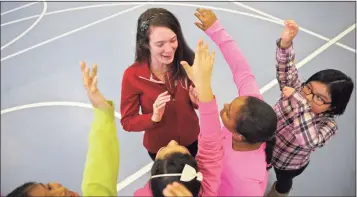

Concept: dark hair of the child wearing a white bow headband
[[150, 153, 201, 197]]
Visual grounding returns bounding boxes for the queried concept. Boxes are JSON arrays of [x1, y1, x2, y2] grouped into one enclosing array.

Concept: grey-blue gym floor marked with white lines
[[1, 2, 356, 196]]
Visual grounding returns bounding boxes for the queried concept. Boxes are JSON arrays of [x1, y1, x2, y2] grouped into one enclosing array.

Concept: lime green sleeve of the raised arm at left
[[82, 101, 119, 196]]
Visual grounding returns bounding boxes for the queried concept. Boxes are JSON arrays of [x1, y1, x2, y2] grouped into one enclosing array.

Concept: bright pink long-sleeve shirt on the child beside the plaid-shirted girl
[[206, 20, 268, 196]]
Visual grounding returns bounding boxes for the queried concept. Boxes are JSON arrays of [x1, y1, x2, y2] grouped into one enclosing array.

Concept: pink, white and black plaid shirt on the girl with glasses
[[272, 39, 337, 170]]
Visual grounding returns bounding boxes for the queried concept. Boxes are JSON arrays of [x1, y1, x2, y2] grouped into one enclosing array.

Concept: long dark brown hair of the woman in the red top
[[135, 8, 195, 80]]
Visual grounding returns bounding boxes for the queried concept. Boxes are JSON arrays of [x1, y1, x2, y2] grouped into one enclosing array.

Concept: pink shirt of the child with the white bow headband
[[134, 99, 224, 196]]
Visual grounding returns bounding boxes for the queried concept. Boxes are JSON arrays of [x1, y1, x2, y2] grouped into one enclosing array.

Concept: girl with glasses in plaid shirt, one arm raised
[[268, 20, 354, 196]]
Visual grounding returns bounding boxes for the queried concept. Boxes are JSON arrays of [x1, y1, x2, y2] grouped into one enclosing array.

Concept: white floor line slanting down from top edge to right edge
[[230, 0, 356, 53]]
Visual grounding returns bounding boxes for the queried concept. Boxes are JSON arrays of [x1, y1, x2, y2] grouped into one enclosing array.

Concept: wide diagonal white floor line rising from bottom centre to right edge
[[117, 24, 356, 192]]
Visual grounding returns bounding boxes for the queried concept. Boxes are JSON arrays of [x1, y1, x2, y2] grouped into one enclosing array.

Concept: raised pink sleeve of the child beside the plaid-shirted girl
[[205, 20, 262, 99]]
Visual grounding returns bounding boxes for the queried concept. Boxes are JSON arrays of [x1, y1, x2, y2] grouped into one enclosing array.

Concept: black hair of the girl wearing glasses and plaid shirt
[[305, 69, 354, 115]]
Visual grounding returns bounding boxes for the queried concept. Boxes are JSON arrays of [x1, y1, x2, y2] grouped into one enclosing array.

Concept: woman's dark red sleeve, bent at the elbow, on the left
[[120, 70, 160, 131]]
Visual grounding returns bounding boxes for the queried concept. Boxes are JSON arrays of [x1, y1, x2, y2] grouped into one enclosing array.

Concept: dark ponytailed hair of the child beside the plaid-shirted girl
[[236, 97, 277, 170]]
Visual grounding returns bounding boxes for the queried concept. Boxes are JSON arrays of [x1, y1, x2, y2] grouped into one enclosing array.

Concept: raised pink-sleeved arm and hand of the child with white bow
[[181, 40, 224, 196]]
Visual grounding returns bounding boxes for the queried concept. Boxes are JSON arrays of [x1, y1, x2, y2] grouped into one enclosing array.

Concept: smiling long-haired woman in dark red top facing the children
[[120, 8, 199, 160]]
